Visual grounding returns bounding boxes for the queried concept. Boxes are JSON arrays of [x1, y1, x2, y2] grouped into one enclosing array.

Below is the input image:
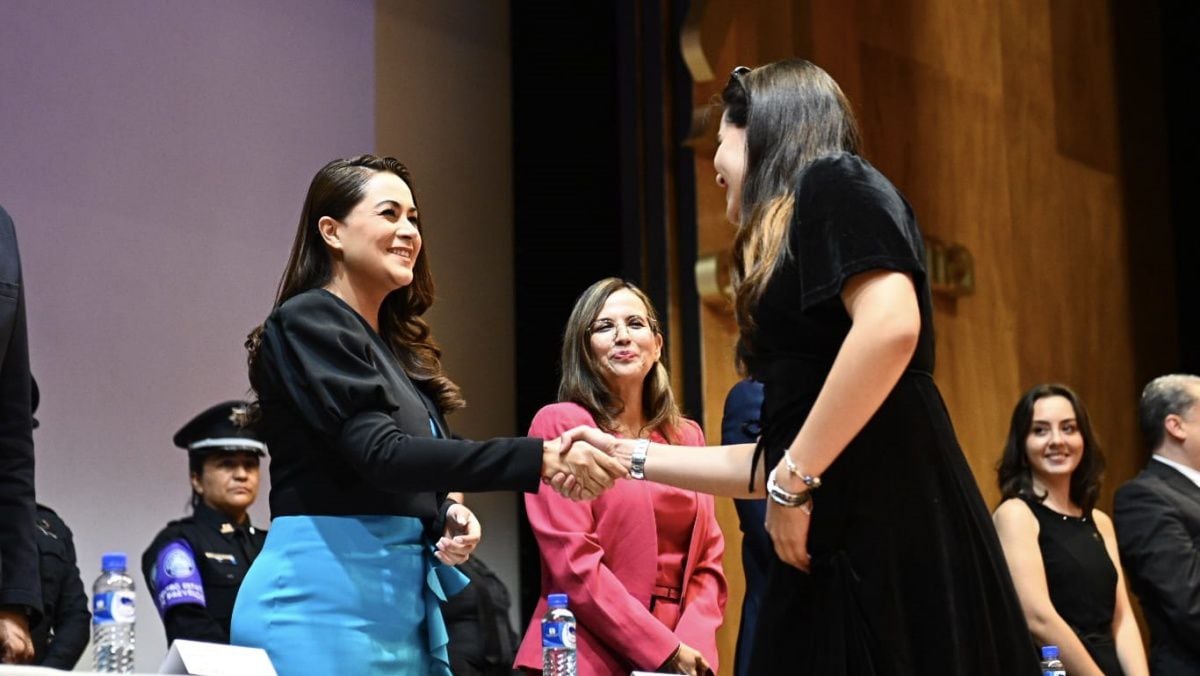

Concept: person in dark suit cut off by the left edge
[[0, 208, 42, 663]]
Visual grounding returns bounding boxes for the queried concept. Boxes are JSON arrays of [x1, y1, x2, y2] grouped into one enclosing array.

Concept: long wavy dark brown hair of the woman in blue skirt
[[246, 155, 466, 417]]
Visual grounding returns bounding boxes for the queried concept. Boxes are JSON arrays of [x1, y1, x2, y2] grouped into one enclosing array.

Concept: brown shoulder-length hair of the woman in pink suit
[[558, 277, 682, 443]]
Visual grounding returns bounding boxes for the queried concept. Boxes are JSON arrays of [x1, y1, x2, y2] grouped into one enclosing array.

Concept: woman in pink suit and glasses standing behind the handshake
[[516, 277, 726, 676]]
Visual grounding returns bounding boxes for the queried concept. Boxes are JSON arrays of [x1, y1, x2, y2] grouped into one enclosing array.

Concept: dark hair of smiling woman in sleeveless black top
[[996, 383, 1104, 515]]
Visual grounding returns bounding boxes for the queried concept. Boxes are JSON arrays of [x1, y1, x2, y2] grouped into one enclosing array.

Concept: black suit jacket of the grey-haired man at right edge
[[1114, 475, 1200, 646]]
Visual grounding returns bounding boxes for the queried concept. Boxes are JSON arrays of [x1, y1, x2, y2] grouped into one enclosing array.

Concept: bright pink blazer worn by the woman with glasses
[[515, 403, 727, 676]]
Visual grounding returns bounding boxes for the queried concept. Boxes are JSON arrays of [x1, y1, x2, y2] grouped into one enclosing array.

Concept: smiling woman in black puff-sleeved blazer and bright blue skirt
[[232, 155, 624, 676]]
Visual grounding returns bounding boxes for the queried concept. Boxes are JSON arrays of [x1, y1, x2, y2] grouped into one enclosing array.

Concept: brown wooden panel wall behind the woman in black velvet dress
[[685, 0, 1175, 656]]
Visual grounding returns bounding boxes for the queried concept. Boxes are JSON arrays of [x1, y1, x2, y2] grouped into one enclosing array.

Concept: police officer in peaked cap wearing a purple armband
[[142, 401, 266, 644]]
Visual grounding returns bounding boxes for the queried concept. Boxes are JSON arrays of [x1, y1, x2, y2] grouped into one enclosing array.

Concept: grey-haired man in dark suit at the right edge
[[1114, 375, 1200, 676]]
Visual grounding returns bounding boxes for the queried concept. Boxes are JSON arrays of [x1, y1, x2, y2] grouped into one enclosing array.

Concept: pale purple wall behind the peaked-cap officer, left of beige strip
[[0, 0, 374, 671]]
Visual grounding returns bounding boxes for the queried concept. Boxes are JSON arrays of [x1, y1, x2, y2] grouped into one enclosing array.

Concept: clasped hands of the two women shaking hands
[[541, 426, 631, 499]]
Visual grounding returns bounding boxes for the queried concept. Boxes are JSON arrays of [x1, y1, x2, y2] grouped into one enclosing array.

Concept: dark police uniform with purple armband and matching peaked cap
[[142, 401, 266, 645]]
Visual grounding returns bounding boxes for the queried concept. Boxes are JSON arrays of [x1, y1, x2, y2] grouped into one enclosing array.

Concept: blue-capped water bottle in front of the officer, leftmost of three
[[91, 552, 137, 674]]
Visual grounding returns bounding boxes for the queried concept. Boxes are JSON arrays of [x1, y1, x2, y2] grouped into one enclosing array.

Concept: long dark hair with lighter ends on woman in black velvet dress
[[721, 59, 859, 369]]
